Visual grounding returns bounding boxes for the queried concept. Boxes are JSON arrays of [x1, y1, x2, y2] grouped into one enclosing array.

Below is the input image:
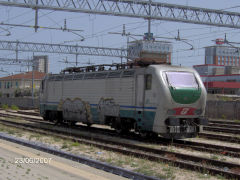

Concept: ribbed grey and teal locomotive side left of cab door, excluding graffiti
[[41, 77, 138, 124]]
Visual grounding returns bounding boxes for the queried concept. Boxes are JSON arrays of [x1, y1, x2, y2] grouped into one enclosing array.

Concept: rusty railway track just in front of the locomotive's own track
[[0, 120, 240, 179]]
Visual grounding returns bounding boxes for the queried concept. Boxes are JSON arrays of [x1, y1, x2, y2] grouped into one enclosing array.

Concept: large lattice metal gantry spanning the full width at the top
[[0, 0, 240, 28]]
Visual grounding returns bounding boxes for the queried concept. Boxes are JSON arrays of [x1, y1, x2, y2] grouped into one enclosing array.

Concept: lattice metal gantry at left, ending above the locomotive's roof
[[0, 40, 127, 58]]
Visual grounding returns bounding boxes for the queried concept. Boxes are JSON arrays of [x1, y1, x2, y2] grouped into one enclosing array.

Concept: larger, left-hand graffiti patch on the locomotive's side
[[59, 98, 91, 123]]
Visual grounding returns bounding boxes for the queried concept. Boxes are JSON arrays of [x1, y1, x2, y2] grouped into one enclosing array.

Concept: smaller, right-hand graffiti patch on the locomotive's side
[[97, 98, 120, 121]]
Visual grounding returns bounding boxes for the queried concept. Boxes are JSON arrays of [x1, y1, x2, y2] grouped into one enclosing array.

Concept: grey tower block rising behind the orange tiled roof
[[33, 56, 49, 73]]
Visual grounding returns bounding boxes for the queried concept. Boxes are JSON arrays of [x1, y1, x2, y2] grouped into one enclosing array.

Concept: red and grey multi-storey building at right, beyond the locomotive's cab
[[193, 39, 240, 95]]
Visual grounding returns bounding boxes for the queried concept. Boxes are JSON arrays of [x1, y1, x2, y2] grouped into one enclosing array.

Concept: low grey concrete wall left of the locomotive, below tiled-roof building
[[0, 97, 39, 109]]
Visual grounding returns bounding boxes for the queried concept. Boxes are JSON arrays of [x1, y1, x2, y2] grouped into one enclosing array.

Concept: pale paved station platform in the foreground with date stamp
[[0, 140, 126, 180]]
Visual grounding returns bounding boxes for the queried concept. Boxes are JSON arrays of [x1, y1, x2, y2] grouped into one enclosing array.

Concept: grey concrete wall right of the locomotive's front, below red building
[[206, 101, 240, 119]]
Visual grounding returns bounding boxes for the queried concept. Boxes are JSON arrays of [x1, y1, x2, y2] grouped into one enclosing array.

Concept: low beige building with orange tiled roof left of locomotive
[[0, 71, 46, 97]]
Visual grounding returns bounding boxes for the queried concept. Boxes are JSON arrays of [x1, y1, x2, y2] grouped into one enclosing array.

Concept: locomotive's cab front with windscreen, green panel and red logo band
[[163, 71, 207, 139]]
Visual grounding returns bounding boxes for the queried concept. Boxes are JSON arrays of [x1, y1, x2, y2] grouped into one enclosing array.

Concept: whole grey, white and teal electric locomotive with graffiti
[[40, 65, 207, 138]]
